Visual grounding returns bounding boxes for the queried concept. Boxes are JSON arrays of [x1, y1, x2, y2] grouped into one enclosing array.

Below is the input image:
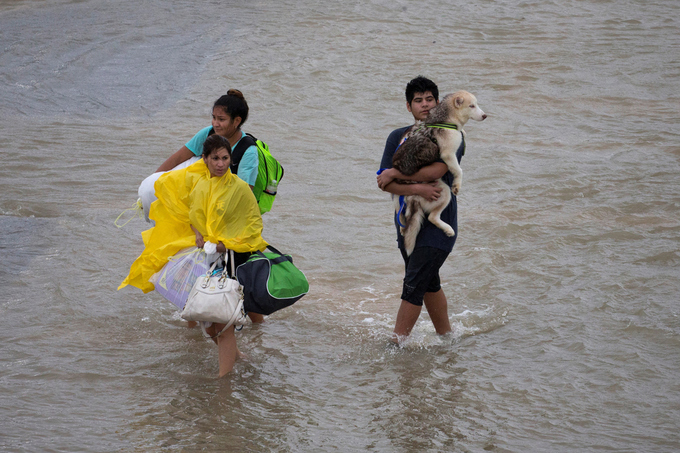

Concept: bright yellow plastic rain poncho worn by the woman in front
[[118, 159, 267, 293]]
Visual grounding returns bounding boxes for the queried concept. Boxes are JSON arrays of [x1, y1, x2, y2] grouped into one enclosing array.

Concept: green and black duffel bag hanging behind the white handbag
[[236, 245, 309, 315]]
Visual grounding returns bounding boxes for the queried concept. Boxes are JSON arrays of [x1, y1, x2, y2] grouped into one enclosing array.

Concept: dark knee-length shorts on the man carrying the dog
[[399, 247, 449, 306]]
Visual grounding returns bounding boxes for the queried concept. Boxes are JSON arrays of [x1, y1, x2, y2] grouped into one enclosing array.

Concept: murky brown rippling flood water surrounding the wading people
[[0, 0, 680, 452]]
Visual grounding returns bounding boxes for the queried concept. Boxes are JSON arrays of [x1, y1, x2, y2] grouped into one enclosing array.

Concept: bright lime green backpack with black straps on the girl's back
[[231, 134, 283, 214]]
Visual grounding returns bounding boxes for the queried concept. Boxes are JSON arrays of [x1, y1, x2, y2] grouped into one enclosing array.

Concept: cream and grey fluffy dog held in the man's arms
[[392, 91, 486, 255]]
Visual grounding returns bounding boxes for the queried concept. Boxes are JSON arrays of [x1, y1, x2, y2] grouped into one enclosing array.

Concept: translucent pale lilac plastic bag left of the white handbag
[[149, 247, 210, 310]]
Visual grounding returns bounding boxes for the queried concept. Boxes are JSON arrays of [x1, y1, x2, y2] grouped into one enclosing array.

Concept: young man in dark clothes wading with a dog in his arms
[[377, 76, 458, 343]]
